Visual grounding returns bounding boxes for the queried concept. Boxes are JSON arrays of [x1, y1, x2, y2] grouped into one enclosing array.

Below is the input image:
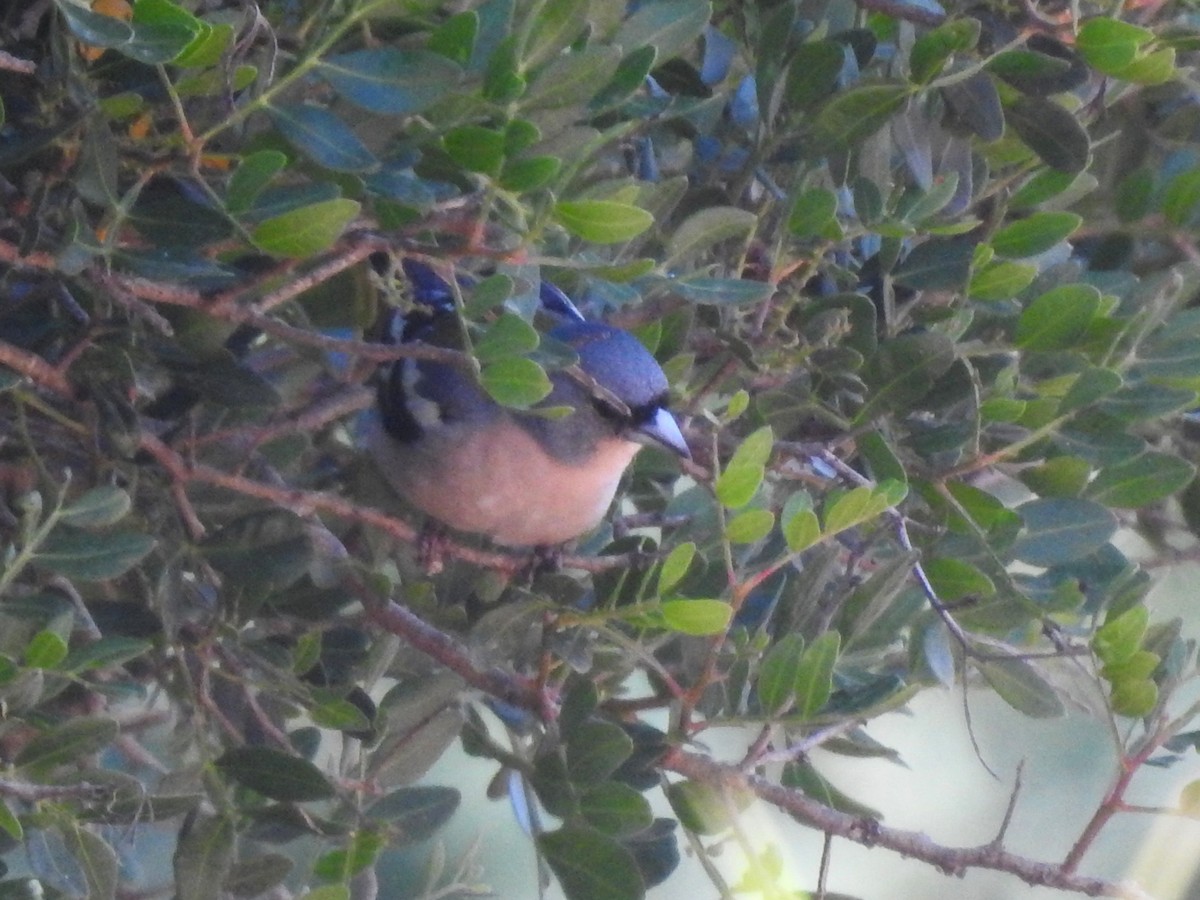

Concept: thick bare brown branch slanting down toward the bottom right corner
[[661, 748, 1150, 900]]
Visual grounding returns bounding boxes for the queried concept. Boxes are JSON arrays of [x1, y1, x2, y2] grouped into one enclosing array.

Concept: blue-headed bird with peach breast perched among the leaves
[[367, 257, 691, 550]]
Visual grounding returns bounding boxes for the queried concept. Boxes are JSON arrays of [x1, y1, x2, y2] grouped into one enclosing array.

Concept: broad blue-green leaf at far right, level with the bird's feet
[[1013, 497, 1117, 566]]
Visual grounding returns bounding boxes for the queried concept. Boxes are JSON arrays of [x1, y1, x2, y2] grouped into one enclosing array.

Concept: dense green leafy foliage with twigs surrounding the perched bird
[[0, 0, 1200, 900]]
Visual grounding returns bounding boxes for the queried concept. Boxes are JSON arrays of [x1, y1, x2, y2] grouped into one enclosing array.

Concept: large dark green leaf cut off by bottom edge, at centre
[[538, 824, 646, 900]]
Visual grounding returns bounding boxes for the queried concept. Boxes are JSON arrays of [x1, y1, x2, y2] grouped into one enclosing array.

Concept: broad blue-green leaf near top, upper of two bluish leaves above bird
[[317, 47, 462, 115]]
